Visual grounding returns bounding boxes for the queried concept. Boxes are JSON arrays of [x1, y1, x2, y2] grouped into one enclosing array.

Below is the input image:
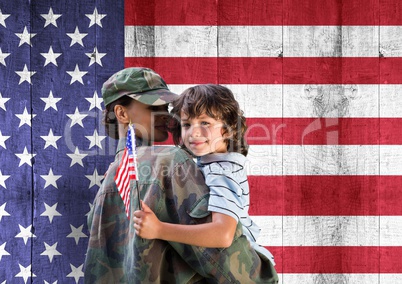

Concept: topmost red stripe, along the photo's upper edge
[[125, 0, 402, 26]]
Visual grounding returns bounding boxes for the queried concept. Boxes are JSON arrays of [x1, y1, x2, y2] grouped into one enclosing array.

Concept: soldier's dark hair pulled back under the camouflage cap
[[102, 96, 133, 139]]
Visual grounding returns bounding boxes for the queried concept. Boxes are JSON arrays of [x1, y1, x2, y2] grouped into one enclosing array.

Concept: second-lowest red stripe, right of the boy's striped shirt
[[248, 175, 402, 216]]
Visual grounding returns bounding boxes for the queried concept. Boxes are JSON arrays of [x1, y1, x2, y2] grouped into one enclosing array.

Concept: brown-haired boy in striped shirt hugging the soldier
[[134, 84, 275, 265]]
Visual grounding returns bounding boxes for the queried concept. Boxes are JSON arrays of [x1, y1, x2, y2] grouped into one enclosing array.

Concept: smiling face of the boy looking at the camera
[[180, 111, 227, 156]]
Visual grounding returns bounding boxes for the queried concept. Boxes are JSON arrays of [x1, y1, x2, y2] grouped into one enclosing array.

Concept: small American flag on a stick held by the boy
[[114, 124, 138, 219]]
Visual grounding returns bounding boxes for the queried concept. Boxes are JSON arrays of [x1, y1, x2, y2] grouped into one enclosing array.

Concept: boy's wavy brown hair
[[170, 84, 248, 156]]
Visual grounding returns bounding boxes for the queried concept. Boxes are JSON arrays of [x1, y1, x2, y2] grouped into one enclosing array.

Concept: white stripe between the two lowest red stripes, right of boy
[[251, 216, 402, 247]]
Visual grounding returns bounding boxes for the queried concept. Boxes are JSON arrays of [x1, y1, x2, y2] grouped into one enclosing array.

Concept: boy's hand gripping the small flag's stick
[[133, 200, 161, 239]]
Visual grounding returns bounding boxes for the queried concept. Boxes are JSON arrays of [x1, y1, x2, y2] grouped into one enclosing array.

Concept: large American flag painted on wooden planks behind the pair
[[0, 0, 402, 284]]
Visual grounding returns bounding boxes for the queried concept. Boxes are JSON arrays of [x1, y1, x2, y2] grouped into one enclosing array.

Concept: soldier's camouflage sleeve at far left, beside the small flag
[[84, 163, 128, 283]]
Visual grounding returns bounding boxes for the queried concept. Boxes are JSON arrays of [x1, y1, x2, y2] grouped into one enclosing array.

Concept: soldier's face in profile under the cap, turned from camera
[[127, 100, 169, 142]]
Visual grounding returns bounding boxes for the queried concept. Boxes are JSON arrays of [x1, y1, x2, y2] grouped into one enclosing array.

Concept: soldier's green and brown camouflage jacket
[[84, 140, 278, 284]]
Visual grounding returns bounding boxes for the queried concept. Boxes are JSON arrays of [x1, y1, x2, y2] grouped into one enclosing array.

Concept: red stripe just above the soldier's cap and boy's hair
[[125, 57, 402, 84]]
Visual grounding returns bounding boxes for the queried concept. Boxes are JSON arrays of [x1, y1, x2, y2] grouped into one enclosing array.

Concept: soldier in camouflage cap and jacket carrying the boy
[[85, 68, 277, 283]]
